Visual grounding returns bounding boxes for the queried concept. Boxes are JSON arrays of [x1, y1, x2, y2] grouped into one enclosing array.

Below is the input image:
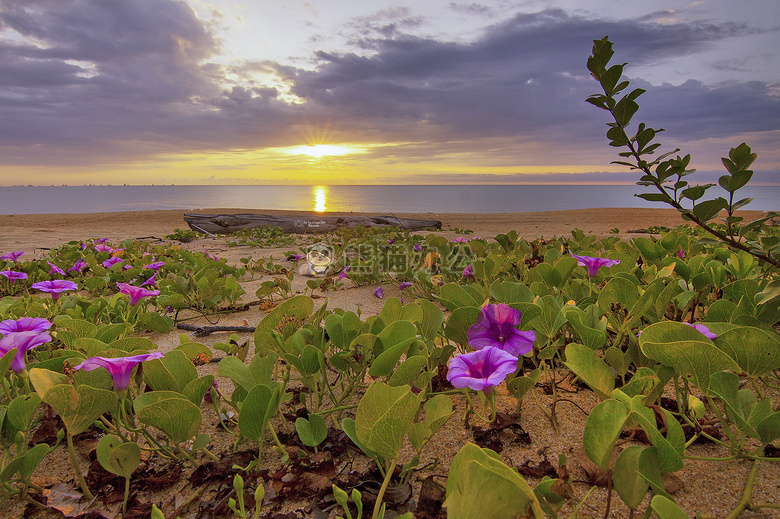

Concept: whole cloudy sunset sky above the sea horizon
[[0, 0, 780, 186]]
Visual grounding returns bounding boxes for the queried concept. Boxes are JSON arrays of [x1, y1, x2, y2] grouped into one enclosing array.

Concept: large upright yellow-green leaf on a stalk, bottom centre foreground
[[355, 382, 421, 460]]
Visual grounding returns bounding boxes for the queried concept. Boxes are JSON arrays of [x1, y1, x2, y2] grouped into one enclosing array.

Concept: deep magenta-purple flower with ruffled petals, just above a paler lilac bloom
[[466, 303, 536, 357]]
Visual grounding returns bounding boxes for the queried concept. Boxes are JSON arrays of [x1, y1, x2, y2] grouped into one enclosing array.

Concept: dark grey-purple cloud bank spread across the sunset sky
[[0, 0, 780, 177]]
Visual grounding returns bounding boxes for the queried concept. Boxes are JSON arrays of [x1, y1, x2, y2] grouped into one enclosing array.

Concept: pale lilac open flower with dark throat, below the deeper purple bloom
[[447, 346, 517, 393]]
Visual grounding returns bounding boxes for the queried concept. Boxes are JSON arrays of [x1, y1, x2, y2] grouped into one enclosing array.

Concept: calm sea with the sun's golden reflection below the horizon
[[0, 185, 780, 214]]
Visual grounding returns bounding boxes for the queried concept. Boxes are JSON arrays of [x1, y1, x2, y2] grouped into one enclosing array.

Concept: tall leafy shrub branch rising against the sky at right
[[586, 36, 780, 267]]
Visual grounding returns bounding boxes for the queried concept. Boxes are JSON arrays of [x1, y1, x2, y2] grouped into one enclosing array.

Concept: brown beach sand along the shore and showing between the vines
[[0, 208, 780, 518]]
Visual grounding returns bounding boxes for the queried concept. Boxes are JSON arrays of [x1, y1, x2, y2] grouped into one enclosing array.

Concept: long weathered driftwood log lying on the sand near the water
[[184, 213, 441, 234]]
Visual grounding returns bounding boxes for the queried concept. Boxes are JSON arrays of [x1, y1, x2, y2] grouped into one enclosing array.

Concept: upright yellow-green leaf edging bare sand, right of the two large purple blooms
[[582, 400, 628, 471]]
